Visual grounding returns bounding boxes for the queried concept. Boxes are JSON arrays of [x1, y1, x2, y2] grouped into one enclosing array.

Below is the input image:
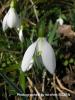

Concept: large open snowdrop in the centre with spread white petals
[[21, 37, 56, 74]]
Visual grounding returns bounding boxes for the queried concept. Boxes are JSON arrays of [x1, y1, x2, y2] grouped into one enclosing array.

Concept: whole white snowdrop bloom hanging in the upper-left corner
[[2, 8, 20, 31]]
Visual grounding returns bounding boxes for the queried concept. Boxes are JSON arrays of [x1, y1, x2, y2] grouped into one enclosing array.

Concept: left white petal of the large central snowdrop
[[21, 42, 37, 71]]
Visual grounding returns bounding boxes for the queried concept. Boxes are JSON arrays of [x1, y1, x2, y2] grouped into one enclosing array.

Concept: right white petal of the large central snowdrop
[[38, 38, 56, 74]]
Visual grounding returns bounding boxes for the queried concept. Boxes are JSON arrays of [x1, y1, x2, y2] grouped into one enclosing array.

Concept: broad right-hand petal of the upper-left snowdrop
[[7, 8, 19, 28]]
